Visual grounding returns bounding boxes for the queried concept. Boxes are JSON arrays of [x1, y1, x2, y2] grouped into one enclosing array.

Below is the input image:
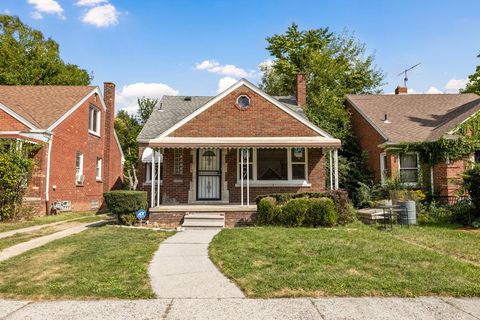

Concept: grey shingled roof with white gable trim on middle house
[[138, 79, 331, 141]]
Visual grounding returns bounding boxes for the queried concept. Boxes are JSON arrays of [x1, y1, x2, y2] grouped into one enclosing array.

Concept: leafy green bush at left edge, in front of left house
[[0, 148, 35, 221]]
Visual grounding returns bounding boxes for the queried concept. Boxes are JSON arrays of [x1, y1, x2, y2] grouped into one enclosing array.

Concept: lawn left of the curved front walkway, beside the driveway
[[0, 226, 172, 299]]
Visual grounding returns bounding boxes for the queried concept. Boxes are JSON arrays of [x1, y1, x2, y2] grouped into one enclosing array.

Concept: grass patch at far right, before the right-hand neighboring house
[[393, 225, 480, 265]]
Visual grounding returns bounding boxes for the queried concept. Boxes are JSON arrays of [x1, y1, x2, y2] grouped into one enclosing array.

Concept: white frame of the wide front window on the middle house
[[235, 148, 311, 187]]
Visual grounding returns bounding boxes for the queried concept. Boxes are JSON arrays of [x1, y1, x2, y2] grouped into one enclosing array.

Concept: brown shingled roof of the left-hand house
[[0, 86, 96, 129]]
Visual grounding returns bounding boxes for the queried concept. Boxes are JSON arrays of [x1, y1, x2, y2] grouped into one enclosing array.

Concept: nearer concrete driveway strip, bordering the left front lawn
[[0, 221, 106, 261]]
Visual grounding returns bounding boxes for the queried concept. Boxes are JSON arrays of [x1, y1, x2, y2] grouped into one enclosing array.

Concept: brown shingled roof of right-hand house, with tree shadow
[[347, 93, 480, 143]]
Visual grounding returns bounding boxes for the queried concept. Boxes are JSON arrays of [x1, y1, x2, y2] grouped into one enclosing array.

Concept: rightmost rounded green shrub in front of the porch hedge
[[305, 197, 339, 227]]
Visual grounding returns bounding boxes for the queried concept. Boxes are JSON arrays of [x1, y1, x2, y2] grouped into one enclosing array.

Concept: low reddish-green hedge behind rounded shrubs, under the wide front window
[[256, 190, 355, 225]]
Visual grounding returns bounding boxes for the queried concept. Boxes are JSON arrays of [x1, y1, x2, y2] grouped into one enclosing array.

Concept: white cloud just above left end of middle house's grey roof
[[116, 82, 178, 114]]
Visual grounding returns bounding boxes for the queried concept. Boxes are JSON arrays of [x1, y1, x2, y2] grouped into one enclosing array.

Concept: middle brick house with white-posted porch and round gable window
[[138, 75, 341, 226]]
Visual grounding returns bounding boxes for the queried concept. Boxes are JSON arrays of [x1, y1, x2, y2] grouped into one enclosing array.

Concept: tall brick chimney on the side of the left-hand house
[[102, 82, 115, 192]]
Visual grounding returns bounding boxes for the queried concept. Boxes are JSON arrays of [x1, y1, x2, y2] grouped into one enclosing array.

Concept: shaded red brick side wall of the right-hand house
[[346, 102, 390, 182]]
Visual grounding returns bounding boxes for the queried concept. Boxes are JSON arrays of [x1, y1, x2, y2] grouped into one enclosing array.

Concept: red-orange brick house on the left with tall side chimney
[[0, 83, 123, 214]]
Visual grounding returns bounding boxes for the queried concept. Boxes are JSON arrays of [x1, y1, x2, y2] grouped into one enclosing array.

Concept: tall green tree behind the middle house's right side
[[261, 23, 384, 200]]
